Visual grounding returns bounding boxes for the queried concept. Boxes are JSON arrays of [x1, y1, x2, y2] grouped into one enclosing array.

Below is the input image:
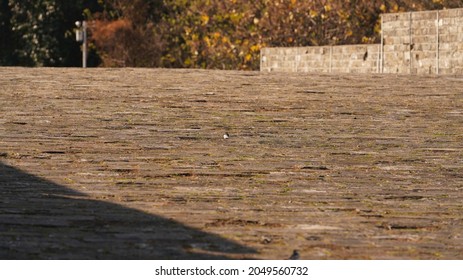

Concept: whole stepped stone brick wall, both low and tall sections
[[261, 9, 463, 74]]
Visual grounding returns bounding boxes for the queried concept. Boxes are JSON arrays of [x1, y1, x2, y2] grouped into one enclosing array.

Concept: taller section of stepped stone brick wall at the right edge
[[382, 9, 463, 74]]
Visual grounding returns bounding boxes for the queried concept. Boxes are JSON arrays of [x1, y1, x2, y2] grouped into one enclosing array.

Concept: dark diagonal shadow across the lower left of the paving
[[0, 162, 255, 259]]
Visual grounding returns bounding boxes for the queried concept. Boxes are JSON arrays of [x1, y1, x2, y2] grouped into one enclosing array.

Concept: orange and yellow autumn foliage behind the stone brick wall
[[91, 0, 463, 69]]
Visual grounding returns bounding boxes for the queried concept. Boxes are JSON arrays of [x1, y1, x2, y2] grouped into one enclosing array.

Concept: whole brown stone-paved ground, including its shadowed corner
[[0, 68, 463, 259]]
